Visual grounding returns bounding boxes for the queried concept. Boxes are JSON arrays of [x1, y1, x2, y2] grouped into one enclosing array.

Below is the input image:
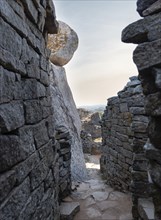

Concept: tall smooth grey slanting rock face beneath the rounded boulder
[[50, 64, 87, 180]]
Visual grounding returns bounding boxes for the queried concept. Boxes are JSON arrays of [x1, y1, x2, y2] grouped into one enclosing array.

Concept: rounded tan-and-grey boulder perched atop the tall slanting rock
[[48, 21, 78, 66]]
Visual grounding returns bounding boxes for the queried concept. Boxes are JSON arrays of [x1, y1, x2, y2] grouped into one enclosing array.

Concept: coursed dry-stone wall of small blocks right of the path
[[100, 77, 148, 192]]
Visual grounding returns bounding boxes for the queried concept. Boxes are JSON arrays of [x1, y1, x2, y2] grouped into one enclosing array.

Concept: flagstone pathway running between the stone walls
[[62, 155, 132, 220]]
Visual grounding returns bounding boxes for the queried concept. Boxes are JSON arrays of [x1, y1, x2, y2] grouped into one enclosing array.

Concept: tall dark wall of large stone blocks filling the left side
[[0, 0, 59, 220]]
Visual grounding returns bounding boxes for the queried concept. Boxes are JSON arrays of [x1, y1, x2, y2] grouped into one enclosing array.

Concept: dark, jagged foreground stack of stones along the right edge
[[122, 0, 161, 220]]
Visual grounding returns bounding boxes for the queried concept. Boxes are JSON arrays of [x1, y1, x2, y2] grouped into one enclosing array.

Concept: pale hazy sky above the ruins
[[54, 0, 140, 106]]
